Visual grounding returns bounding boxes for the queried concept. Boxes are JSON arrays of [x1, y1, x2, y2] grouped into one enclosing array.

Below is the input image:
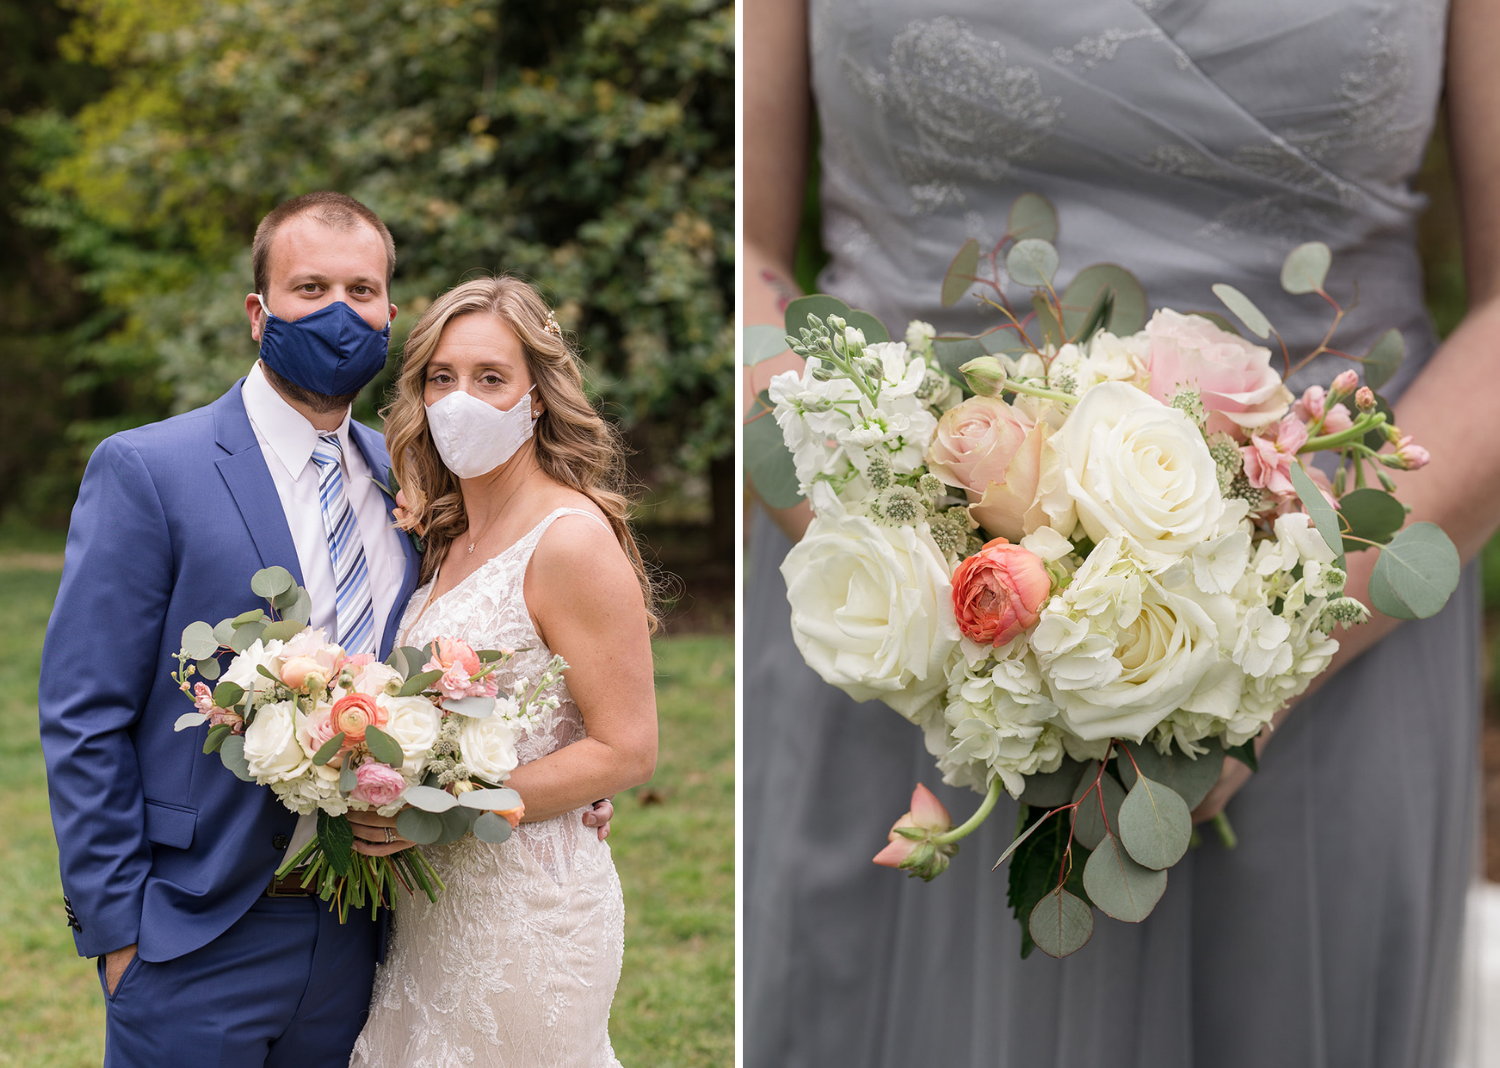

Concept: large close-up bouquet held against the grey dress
[[746, 195, 1458, 957]]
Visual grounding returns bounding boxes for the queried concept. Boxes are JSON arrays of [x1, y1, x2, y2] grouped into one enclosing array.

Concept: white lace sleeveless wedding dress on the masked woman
[[350, 509, 626, 1068]]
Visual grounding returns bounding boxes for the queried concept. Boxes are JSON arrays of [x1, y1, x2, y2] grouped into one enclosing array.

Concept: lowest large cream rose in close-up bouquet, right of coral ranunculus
[[1029, 539, 1242, 741]]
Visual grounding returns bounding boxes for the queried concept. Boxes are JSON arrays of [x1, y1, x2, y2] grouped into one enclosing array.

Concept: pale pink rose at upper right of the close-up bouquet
[[1146, 308, 1292, 441]]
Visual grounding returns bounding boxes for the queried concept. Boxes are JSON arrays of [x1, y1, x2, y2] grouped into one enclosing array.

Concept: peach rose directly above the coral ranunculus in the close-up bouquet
[[927, 396, 1052, 539]]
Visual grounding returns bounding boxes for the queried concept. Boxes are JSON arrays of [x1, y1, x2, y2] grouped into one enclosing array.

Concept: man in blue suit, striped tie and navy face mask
[[39, 192, 608, 1068]]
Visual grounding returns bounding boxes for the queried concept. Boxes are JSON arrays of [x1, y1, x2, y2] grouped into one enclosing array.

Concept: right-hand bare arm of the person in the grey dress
[[1193, 0, 1500, 819]]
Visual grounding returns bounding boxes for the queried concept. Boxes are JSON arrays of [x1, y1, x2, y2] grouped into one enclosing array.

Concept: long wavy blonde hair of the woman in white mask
[[381, 276, 657, 633]]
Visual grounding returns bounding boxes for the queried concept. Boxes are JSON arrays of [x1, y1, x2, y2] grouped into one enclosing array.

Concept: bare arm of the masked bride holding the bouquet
[[506, 516, 657, 822]]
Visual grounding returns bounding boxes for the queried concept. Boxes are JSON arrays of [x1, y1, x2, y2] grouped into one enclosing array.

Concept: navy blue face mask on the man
[[257, 296, 390, 398]]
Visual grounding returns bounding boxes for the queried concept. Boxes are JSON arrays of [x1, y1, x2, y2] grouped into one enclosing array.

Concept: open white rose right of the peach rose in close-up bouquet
[[1026, 383, 1224, 569]]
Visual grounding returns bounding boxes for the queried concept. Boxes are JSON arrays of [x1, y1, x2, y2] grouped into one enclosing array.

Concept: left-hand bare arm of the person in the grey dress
[[740, 0, 813, 542]]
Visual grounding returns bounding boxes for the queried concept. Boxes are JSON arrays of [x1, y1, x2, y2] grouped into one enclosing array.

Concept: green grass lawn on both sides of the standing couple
[[0, 564, 735, 1068]]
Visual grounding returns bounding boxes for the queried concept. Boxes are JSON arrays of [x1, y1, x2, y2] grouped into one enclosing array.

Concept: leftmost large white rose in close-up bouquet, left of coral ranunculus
[[782, 486, 959, 719]]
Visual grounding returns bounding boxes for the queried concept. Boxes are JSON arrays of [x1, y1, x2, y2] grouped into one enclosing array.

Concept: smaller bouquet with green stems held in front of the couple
[[173, 567, 567, 921]]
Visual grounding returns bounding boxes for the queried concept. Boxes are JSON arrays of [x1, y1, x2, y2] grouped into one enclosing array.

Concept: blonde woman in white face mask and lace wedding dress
[[351, 278, 657, 1068]]
